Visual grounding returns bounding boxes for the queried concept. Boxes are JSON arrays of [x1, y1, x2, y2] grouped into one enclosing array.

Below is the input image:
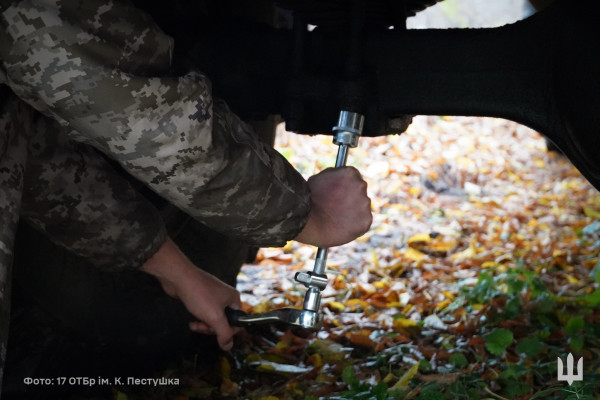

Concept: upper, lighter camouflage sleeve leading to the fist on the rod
[[0, 0, 310, 246]]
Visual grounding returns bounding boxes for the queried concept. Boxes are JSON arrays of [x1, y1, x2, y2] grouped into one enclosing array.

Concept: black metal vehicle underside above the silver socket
[[143, 0, 600, 187]]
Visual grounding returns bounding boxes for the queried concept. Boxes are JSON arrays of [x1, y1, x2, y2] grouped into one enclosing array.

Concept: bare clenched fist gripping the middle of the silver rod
[[295, 167, 373, 247]]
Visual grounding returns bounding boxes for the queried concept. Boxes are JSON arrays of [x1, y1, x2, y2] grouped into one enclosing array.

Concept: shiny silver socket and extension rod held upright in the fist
[[294, 111, 364, 328]]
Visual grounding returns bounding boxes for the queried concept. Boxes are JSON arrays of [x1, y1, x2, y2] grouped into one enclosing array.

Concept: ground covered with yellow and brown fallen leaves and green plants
[[126, 117, 600, 400]]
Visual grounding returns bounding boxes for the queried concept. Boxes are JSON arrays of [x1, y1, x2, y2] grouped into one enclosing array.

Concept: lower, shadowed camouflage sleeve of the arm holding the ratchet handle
[[21, 103, 166, 270]]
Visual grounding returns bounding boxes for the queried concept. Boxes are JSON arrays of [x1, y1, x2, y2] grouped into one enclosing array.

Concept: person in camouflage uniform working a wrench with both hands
[[0, 0, 371, 394]]
